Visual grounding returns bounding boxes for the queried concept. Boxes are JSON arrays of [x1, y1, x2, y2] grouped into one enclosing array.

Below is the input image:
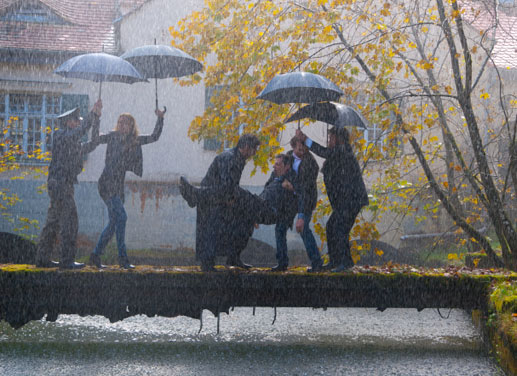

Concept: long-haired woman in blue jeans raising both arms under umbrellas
[[90, 109, 166, 269]]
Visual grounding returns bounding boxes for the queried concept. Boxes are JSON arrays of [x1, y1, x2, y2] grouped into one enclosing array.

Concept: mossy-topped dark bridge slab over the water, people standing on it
[[0, 264, 496, 328]]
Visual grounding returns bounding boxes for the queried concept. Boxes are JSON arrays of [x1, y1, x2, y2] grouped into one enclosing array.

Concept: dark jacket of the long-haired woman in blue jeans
[[92, 117, 163, 200]]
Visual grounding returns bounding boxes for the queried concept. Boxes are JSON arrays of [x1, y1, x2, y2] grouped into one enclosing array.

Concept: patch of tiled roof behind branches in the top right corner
[[464, 2, 517, 69]]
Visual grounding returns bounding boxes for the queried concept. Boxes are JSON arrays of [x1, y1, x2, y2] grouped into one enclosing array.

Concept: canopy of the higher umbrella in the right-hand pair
[[258, 72, 343, 104]]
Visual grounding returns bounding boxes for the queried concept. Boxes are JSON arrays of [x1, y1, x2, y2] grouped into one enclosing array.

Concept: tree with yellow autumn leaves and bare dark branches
[[170, 0, 517, 269]]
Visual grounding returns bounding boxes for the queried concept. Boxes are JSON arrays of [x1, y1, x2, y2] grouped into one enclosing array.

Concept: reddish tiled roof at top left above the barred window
[[0, 0, 149, 57]]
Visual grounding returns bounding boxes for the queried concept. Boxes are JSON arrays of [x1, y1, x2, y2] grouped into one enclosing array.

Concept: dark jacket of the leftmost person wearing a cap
[[48, 112, 100, 184]]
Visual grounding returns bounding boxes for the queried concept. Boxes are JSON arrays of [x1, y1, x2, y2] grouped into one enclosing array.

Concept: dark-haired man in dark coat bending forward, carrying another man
[[180, 134, 260, 271]]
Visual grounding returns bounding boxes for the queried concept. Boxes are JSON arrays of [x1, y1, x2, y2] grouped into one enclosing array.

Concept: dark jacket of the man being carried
[[260, 170, 297, 225]]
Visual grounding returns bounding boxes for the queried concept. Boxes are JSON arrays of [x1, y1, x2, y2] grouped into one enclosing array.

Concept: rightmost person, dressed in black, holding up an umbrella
[[296, 128, 368, 272]]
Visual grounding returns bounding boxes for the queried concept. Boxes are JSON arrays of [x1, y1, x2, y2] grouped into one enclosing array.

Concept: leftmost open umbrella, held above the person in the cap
[[54, 52, 147, 98]]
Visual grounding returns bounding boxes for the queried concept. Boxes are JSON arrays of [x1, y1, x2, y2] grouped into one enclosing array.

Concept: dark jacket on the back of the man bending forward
[[201, 148, 246, 201]]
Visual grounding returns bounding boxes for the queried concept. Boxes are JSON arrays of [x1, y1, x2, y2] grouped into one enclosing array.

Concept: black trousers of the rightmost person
[[326, 207, 361, 267]]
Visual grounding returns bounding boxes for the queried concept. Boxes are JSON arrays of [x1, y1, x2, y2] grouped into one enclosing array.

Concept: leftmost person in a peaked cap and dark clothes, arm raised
[[36, 99, 102, 269]]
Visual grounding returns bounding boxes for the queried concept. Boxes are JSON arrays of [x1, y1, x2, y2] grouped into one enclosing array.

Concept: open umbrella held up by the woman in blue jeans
[[120, 42, 203, 108]]
